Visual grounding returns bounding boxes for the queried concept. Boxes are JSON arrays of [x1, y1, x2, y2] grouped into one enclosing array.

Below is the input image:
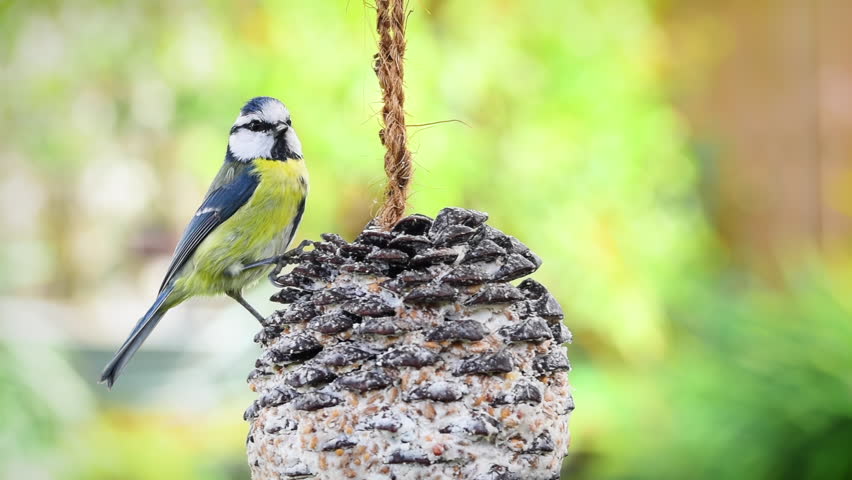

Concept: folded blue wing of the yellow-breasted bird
[[160, 163, 260, 292]]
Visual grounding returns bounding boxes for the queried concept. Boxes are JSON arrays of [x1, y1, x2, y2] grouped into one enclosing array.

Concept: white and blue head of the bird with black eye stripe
[[228, 97, 302, 162]]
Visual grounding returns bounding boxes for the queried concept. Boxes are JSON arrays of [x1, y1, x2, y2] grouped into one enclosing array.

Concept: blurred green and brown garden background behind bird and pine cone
[[0, 0, 852, 480]]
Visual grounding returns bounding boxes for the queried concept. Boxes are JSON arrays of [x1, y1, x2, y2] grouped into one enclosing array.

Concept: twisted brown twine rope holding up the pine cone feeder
[[373, 0, 412, 230]]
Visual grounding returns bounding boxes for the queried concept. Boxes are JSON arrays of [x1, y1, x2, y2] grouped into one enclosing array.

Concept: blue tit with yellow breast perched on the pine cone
[[100, 97, 308, 388]]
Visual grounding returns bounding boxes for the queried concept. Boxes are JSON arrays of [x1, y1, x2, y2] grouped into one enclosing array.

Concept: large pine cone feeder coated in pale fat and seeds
[[245, 208, 574, 480]]
